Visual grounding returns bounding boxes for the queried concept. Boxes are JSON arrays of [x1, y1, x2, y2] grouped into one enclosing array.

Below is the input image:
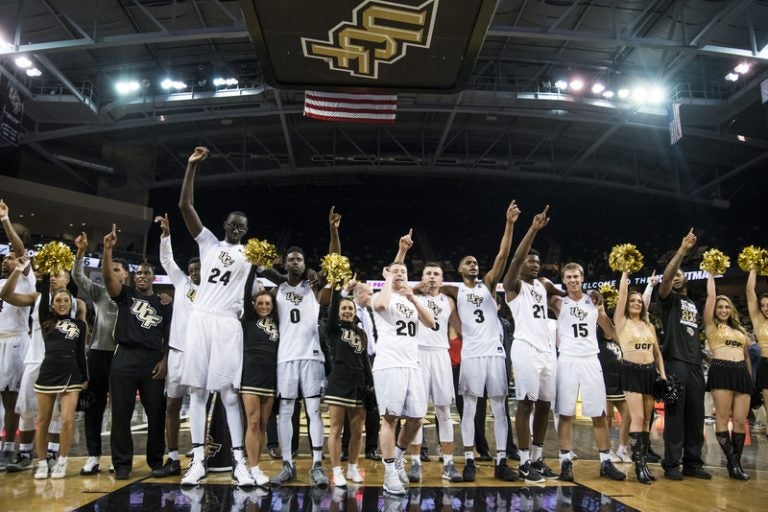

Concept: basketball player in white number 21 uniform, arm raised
[[504, 206, 564, 483]]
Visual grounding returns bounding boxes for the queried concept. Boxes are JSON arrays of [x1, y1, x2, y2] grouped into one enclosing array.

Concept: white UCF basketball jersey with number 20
[[373, 292, 425, 370]]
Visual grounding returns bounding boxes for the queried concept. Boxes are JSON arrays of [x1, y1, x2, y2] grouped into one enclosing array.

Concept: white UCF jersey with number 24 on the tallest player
[[195, 228, 251, 316]]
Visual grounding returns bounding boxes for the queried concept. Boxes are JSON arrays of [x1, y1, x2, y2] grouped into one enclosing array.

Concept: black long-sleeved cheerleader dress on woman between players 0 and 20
[[325, 290, 373, 407]]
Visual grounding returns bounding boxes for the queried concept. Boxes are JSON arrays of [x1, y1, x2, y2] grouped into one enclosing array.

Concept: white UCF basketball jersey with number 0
[[276, 280, 325, 363]]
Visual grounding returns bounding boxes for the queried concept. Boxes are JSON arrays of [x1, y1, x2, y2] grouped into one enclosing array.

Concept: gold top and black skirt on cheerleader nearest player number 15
[[619, 320, 656, 395]]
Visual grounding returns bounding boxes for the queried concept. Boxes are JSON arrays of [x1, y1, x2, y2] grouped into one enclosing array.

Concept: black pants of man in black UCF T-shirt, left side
[[110, 345, 165, 471]]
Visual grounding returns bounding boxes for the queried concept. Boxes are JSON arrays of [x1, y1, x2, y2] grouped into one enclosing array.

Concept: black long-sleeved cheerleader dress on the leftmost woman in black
[[35, 276, 88, 394]]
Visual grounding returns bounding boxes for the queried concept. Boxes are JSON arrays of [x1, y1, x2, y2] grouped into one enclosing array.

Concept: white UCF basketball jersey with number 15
[[557, 294, 600, 356]]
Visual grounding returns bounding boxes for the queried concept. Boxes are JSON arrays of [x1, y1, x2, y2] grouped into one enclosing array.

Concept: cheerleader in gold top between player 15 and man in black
[[613, 271, 667, 484]]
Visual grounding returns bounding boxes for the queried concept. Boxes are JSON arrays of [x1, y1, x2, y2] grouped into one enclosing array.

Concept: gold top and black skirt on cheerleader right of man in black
[[705, 324, 752, 394]]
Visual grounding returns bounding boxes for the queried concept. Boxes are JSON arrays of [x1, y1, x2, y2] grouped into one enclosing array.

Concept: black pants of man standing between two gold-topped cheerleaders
[[662, 359, 704, 469]]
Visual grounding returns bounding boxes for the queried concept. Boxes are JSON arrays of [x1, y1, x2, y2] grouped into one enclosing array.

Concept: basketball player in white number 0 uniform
[[267, 207, 341, 487]]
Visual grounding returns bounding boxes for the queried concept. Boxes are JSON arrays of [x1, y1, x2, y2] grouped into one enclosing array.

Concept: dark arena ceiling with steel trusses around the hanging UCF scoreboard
[[0, 0, 768, 212]]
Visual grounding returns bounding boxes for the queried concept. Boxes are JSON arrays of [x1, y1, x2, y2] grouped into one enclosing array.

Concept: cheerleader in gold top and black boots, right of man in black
[[704, 275, 752, 480]]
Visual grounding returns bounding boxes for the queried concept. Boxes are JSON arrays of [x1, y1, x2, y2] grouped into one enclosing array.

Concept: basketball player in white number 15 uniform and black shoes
[[553, 263, 627, 482]]
